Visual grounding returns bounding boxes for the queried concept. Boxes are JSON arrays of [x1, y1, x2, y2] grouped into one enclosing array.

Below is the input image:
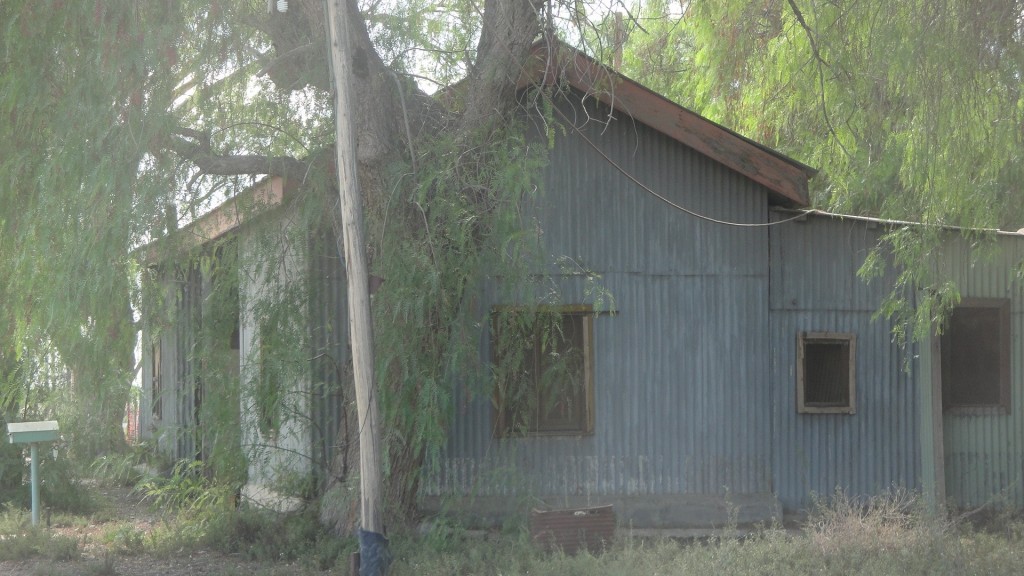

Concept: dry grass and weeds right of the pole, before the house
[[390, 493, 1024, 576]]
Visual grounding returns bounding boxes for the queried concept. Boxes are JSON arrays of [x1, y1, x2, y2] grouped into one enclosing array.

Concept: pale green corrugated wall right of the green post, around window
[[942, 230, 1024, 507]]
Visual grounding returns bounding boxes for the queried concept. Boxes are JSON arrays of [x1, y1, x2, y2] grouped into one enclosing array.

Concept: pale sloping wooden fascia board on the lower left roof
[[142, 176, 288, 263]]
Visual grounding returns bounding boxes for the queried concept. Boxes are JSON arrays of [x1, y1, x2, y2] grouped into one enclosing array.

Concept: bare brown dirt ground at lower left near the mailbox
[[0, 488, 330, 576]]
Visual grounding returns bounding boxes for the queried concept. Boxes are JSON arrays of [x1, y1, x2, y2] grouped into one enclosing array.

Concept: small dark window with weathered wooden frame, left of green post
[[797, 332, 857, 414]]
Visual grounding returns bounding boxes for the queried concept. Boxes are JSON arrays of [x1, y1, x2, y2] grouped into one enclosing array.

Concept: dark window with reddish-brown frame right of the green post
[[940, 298, 1010, 412]]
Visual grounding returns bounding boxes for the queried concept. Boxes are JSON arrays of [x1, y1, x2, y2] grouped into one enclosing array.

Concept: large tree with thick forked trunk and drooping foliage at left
[[0, 0, 630, 526]]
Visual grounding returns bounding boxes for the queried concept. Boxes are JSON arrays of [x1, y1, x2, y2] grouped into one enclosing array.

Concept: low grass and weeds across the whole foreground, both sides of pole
[[0, 481, 1024, 576]]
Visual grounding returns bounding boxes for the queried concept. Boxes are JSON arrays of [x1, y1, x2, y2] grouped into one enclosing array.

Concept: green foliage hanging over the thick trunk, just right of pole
[[368, 119, 545, 504]]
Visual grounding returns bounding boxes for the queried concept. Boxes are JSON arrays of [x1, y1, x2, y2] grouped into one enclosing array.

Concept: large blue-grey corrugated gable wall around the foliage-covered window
[[424, 93, 771, 496]]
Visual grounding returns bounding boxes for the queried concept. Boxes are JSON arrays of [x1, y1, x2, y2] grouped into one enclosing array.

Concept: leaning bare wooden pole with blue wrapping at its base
[[327, 0, 389, 576]]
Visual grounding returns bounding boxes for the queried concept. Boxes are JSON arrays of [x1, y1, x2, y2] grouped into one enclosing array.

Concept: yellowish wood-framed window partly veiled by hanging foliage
[[492, 306, 594, 437]]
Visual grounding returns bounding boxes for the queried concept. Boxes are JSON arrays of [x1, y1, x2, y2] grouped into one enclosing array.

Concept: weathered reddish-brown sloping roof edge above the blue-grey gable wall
[[518, 40, 817, 207]]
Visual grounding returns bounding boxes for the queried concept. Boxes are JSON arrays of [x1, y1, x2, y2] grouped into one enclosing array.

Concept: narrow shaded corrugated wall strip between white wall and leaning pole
[[309, 222, 354, 483]]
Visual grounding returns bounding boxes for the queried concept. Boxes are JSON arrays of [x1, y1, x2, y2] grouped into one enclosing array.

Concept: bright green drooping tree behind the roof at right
[[624, 0, 1024, 337]]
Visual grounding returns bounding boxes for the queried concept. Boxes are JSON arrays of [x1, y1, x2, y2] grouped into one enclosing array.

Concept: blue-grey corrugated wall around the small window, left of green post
[[771, 216, 921, 510]]
